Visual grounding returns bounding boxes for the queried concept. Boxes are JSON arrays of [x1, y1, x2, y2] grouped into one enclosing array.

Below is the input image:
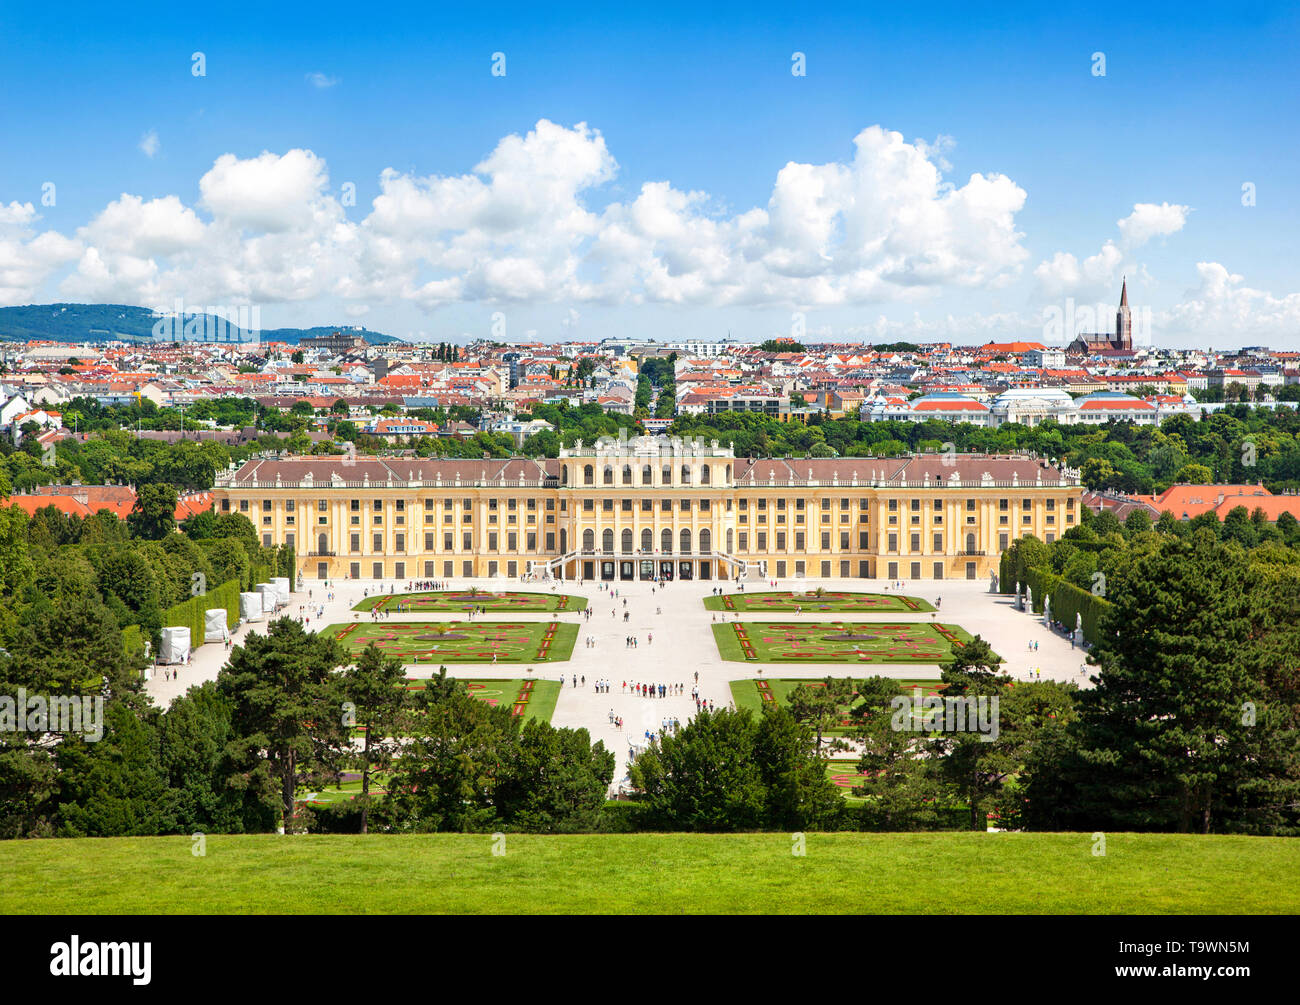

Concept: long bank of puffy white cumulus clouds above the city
[[30, 118, 1027, 309]]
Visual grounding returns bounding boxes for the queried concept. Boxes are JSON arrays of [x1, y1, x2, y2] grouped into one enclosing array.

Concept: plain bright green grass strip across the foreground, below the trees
[[0, 832, 1300, 915]]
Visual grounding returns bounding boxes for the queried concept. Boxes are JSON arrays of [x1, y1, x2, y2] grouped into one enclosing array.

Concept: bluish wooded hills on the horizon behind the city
[[0, 304, 402, 345]]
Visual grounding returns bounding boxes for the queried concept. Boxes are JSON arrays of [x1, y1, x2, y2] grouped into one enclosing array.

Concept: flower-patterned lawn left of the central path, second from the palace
[[321, 621, 577, 666]]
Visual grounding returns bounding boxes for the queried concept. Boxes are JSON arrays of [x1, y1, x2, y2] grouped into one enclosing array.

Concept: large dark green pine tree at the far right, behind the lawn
[[1076, 528, 1300, 833]]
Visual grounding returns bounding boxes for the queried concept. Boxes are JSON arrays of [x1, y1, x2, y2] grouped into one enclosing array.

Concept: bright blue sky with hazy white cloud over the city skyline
[[0, 4, 1300, 345]]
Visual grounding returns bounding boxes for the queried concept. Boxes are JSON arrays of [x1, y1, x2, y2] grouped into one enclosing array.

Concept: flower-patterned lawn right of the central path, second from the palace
[[712, 621, 971, 666]]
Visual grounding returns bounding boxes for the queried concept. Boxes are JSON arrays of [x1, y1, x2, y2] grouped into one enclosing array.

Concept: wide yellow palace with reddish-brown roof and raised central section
[[213, 436, 1082, 580]]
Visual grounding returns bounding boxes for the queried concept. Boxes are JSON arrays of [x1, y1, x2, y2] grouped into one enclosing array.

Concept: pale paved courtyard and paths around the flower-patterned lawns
[[147, 579, 1087, 787]]
